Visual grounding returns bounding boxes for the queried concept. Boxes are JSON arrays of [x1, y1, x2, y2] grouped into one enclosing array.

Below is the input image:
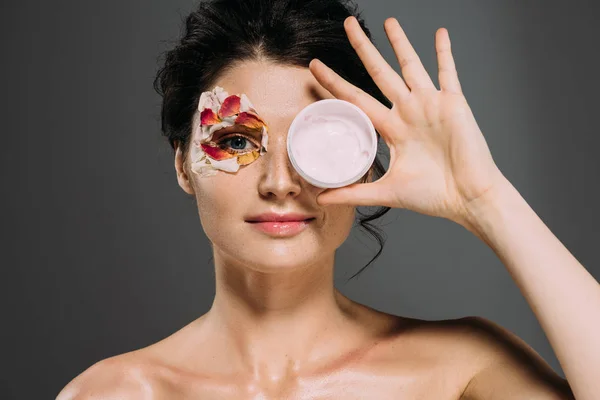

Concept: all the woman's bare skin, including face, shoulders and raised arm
[[58, 14, 600, 400]]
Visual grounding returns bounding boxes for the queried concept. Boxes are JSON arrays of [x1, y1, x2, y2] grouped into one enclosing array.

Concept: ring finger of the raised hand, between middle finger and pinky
[[384, 18, 435, 89]]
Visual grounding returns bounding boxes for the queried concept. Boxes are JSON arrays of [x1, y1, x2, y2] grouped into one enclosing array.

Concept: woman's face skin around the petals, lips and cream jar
[[176, 61, 355, 272]]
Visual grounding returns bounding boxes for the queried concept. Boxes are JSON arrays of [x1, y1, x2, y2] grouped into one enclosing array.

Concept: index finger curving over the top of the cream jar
[[308, 58, 390, 141]]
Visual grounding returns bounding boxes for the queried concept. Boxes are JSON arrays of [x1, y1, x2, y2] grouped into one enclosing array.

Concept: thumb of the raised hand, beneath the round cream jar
[[317, 182, 386, 206]]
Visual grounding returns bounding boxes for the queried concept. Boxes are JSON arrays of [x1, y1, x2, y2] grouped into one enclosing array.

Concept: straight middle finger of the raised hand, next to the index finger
[[344, 17, 410, 102]]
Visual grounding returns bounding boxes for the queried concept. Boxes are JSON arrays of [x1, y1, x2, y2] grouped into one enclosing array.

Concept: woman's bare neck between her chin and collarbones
[[208, 245, 361, 380]]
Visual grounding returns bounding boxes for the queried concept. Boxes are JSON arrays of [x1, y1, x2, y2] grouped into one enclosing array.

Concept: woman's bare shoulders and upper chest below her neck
[[58, 293, 570, 400]]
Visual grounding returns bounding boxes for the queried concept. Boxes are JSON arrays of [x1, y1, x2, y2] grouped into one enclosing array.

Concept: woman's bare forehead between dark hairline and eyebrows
[[215, 61, 334, 123]]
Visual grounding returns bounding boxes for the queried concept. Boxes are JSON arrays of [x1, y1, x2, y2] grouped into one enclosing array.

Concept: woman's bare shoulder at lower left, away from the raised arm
[[56, 352, 168, 400]]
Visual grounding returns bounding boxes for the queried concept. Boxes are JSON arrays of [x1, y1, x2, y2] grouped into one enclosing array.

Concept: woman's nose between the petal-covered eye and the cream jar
[[258, 135, 302, 200]]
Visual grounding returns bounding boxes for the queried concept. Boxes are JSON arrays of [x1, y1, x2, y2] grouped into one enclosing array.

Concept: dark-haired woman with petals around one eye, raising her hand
[[58, 0, 600, 400]]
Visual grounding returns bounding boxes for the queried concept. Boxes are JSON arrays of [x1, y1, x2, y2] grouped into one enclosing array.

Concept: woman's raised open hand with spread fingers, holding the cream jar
[[310, 17, 504, 222]]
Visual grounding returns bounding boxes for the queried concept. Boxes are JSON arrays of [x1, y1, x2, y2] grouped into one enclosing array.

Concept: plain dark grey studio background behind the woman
[[0, 0, 600, 399]]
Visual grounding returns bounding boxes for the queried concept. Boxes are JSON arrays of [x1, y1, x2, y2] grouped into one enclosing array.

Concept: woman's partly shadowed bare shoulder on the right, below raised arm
[[364, 316, 574, 400]]
